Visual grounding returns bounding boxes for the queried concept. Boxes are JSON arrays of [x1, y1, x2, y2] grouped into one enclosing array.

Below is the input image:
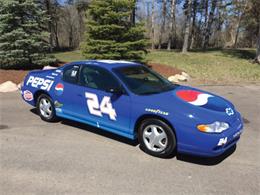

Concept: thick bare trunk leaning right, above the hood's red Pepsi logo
[[182, 0, 191, 53]]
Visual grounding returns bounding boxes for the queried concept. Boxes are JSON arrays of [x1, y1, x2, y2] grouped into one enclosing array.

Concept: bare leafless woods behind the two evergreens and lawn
[[0, 0, 260, 69]]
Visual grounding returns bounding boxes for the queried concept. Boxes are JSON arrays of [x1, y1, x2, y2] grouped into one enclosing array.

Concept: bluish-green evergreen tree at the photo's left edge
[[0, 0, 55, 68]]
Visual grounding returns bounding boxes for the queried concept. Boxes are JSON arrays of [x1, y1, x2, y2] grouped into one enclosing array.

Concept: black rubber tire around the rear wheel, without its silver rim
[[36, 94, 57, 122]]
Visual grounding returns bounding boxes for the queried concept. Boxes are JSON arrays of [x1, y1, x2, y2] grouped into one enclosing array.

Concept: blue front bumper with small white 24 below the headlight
[[177, 113, 243, 157]]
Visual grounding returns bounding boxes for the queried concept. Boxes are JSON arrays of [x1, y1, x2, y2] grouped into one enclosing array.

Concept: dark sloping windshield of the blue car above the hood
[[115, 66, 175, 95]]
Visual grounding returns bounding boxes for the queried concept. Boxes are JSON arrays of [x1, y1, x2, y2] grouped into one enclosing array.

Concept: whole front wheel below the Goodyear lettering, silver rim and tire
[[138, 119, 176, 158]]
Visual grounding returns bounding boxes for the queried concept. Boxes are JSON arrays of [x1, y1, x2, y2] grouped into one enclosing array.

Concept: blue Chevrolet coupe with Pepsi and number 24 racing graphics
[[21, 60, 243, 157]]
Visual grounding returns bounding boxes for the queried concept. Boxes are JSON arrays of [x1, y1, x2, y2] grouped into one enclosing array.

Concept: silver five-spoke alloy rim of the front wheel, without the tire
[[143, 125, 168, 152]]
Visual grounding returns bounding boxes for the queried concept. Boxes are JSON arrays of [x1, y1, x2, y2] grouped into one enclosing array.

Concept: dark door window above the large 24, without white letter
[[80, 66, 120, 91]]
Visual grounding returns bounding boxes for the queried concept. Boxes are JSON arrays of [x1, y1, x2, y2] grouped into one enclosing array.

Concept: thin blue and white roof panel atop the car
[[67, 60, 142, 69]]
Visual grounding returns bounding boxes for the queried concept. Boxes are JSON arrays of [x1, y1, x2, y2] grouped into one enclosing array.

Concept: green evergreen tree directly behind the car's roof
[[82, 0, 147, 60]]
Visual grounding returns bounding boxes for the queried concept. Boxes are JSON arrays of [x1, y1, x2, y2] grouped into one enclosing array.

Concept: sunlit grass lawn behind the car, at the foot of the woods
[[55, 49, 260, 84]]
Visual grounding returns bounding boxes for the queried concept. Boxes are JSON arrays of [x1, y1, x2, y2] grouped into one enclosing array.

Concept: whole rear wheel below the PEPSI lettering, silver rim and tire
[[36, 94, 57, 122]]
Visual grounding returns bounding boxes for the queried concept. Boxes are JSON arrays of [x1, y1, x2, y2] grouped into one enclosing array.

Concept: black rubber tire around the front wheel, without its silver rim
[[138, 118, 176, 158]]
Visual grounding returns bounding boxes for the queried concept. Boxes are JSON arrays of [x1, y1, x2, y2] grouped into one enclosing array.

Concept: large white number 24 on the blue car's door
[[85, 92, 116, 121]]
